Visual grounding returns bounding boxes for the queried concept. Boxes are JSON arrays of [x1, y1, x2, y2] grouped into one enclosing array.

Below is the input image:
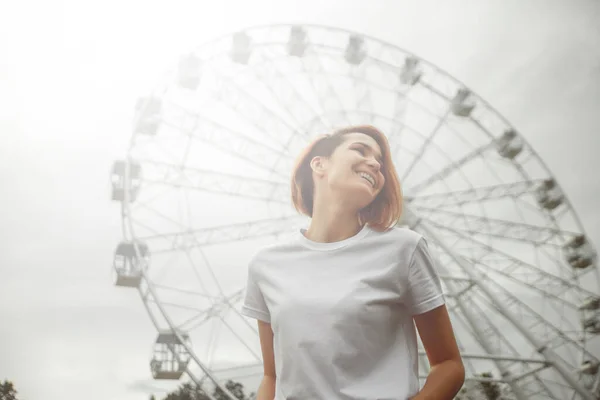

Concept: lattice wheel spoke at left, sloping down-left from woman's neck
[[139, 215, 304, 254]]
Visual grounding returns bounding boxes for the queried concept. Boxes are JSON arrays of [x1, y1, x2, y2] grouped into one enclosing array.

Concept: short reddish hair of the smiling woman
[[292, 125, 402, 231]]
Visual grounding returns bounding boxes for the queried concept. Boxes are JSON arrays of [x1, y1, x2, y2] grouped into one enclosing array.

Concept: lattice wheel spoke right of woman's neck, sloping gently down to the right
[[414, 206, 579, 247]]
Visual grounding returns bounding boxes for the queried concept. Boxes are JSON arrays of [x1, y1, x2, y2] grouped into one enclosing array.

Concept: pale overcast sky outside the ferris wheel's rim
[[0, 0, 600, 400]]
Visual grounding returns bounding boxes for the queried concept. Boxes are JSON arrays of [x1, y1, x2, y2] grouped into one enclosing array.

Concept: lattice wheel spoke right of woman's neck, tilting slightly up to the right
[[410, 180, 542, 208]]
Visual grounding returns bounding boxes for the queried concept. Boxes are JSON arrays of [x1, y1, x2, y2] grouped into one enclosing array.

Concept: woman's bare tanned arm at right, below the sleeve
[[411, 305, 465, 400]]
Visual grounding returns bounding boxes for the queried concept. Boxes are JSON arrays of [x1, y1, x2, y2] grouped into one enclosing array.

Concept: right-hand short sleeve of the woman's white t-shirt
[[407, 237, 445, 315]]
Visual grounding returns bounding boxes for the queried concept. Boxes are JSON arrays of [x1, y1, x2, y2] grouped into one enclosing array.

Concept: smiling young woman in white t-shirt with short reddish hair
[[242, 126, 464, 400]]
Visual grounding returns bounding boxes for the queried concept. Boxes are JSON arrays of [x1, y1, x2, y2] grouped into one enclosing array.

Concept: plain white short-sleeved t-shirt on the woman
[[241, 226, 444, 400]]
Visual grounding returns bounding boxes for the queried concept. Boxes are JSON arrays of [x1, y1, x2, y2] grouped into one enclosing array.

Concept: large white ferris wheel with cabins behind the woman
[[112, 25, 600, 400]]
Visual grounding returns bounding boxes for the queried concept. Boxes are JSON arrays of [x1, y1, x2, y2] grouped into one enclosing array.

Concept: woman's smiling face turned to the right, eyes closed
[[322, 133, 385, 208]]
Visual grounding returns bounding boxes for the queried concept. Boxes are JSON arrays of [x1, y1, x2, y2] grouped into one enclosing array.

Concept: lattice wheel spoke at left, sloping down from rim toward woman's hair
[[135, 160, 289, 204]]
